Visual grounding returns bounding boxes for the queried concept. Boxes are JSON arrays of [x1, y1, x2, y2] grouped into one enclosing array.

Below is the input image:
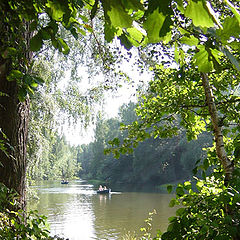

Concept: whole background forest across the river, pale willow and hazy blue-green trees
[[28, 99, 212, 190]]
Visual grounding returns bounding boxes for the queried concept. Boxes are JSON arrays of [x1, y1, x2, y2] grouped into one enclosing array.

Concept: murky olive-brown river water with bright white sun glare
[[29, 180, 176, 240]]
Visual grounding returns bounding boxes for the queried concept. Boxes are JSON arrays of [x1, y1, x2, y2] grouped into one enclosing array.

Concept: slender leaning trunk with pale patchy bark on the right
[[201, 73, 234, 185]]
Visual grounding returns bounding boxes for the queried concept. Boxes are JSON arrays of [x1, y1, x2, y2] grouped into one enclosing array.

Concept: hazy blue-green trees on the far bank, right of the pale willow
[[78, 102, 212, 189]]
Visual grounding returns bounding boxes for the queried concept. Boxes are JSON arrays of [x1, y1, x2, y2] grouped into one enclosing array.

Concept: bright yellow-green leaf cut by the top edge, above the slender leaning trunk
[[184, 0, 214, 27]]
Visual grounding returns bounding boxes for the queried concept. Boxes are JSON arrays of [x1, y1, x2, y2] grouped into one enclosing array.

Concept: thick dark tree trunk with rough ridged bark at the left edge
[[0, 18, 31, 209]]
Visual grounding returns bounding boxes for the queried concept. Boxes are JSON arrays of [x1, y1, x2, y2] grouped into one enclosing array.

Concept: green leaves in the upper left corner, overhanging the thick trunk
[[0, 0, 95, 101]]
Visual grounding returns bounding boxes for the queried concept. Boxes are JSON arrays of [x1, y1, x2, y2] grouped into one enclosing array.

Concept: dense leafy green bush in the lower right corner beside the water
[[161, 171, 240, 239]]
